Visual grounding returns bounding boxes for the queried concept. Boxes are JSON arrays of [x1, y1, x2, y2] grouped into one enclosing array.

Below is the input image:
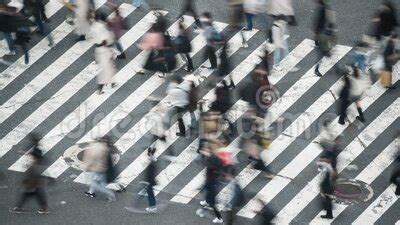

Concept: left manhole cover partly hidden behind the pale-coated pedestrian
[[63, 142, 120, 171]]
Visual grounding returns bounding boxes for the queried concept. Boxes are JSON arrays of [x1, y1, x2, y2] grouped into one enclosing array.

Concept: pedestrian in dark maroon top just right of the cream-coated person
[[107, 8, 127, 59]]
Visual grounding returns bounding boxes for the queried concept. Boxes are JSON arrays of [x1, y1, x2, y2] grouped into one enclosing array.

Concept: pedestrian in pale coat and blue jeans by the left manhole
[[83, 138, 116, 202]]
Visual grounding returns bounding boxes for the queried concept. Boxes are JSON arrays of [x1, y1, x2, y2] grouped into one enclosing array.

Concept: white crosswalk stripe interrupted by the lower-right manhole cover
[[311, 140, 397, 224]]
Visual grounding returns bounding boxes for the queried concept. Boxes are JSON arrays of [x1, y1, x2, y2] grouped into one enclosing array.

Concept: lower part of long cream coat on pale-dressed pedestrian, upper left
[[94, 46, 117, 84]]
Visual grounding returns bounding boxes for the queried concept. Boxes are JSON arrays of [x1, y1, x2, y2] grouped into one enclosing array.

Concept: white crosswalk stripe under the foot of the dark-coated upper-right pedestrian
[[266, 45, 351, 127]]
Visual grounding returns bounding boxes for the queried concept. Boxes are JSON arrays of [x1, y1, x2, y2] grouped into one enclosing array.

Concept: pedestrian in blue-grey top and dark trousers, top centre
[[203, 12, 222, 70]]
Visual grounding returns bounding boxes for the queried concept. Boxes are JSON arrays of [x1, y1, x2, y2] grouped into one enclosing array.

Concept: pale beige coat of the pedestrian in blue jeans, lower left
[[83, 142, 109, 173]]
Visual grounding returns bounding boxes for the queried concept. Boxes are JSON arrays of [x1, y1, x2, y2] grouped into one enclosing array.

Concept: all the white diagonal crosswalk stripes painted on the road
[[0, 4, 400, 224]]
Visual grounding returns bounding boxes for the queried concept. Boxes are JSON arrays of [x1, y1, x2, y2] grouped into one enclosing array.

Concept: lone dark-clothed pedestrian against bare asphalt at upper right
[[314, 0, 336, 77]]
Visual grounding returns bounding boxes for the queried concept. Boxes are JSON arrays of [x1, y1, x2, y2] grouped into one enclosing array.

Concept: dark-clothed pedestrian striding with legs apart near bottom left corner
[[10, 136, 50, 214]]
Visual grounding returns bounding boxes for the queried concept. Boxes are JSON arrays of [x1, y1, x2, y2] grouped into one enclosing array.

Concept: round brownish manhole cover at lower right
[[332, 178, 374, 205]]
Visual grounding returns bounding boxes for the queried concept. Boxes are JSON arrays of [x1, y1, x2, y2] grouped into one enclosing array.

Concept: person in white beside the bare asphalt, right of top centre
[[271, 17, 289, 71]]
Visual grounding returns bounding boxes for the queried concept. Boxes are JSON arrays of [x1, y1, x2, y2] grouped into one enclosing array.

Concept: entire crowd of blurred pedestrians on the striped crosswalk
[[0, 0, 400, 224]]
